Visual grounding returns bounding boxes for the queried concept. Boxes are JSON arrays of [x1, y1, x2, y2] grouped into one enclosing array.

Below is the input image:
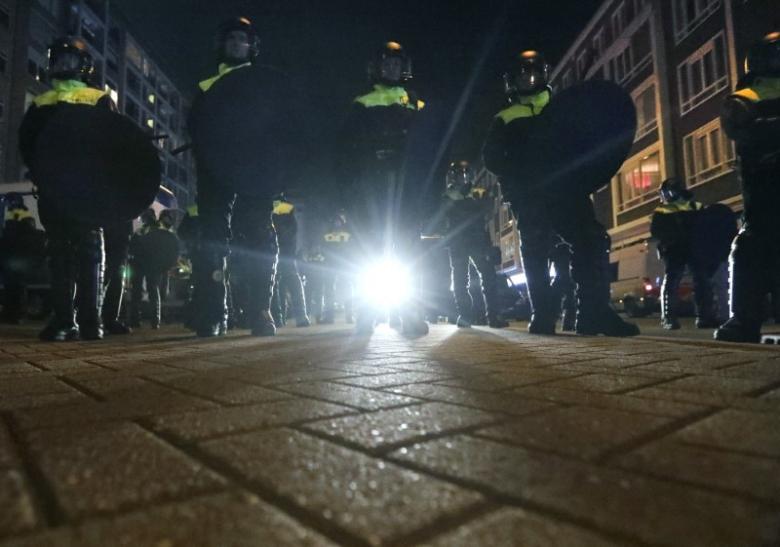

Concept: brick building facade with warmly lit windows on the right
[[552, 0, 780, 297]]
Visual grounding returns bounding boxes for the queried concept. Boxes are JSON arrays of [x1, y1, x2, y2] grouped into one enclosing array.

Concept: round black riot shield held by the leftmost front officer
[[30, 105, 160, 225]]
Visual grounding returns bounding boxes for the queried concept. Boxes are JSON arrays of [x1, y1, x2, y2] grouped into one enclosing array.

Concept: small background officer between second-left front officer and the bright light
[[272, 194, 311, 327]]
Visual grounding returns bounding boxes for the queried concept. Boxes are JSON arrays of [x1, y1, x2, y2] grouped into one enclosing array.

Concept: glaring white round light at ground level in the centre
[[358, 257, 412, 310]]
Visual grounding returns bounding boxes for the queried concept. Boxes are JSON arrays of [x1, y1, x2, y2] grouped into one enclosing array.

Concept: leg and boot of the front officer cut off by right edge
[[715, 225, 772, 343]]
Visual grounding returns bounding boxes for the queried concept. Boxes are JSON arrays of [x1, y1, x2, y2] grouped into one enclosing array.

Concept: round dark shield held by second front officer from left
[[190, 66, 309, 198]]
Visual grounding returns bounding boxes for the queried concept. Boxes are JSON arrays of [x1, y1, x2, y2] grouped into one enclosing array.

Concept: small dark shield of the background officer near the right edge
[[692, 203, 737, 276]]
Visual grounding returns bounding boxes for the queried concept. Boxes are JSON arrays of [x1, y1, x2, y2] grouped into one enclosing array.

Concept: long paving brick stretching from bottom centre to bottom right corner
[[390, 436, 780, 547]]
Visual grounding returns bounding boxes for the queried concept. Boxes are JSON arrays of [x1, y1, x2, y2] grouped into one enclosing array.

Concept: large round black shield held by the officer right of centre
[[513, 80, 637, 194]]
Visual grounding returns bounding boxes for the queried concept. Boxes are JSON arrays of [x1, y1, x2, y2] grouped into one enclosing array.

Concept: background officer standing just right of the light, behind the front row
[[444, 161, 509, 328]]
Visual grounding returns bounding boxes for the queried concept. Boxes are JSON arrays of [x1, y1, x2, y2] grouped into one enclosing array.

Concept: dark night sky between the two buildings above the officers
[[113, 0, 601, 204]]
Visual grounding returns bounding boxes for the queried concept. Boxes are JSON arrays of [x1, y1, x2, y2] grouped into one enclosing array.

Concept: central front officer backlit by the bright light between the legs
[[339, 42, 428, 335]]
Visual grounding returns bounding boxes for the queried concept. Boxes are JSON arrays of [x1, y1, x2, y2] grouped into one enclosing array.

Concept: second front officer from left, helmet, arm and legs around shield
[[190, 17, 277, 337]]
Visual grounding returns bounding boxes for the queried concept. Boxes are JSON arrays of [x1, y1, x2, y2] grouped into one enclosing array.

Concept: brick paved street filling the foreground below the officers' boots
[[0, 325, 780, 547]]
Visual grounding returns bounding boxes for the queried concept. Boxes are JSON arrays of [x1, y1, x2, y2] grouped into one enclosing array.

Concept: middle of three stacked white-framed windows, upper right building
[[677, 32, 729, 114]]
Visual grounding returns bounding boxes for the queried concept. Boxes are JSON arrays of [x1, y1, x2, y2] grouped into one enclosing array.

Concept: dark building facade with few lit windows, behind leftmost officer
[[0, 0, 195, 208]]
